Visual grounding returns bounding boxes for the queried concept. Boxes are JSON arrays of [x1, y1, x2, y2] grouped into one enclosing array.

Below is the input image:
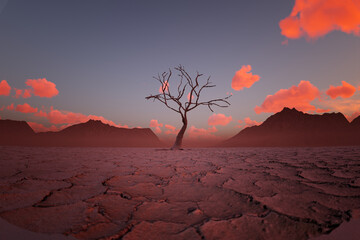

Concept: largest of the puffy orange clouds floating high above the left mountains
[[25, 78, 59, 98]]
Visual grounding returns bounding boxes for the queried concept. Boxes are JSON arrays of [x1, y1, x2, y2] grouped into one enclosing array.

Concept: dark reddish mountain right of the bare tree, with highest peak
[[221, 108, 360, 147]]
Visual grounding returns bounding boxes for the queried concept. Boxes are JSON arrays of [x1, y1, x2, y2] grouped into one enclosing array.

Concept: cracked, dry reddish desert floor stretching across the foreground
[[0, 147, 360, 239]]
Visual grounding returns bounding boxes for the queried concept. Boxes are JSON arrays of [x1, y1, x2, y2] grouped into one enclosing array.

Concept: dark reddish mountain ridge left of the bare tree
[[0, 120, 162, 147]]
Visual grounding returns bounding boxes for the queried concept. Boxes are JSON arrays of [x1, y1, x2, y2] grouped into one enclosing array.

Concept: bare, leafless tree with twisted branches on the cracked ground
[[145, 65, 231, 149]]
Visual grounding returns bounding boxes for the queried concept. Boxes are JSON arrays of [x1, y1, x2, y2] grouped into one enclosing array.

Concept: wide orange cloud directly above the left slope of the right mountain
[[254, 81, 320, 114]]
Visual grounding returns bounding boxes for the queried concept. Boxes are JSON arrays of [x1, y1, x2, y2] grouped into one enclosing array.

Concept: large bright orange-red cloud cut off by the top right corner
[[279, 0, 360, 39]]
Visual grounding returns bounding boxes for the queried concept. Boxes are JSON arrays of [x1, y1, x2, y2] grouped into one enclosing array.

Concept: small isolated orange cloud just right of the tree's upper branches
[[231, 65, 260, 91]]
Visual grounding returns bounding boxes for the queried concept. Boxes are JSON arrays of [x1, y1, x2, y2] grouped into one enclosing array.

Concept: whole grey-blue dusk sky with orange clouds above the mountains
[[0, 0, 360, 140]]
